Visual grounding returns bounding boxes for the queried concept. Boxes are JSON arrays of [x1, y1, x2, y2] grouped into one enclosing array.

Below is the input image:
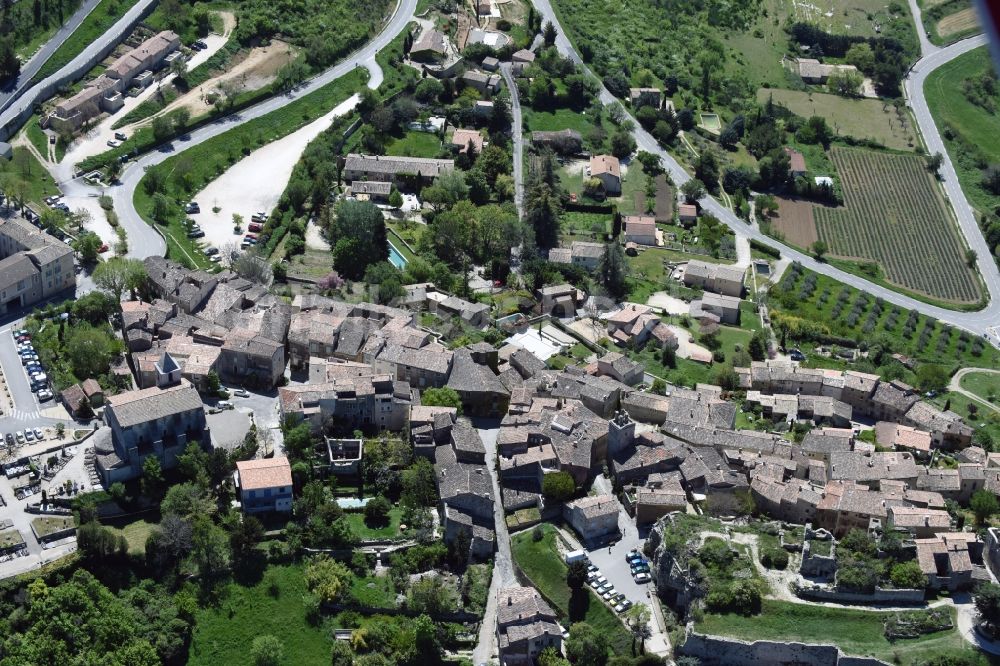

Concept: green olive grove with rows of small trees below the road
[[769, 262, 1000, 370]]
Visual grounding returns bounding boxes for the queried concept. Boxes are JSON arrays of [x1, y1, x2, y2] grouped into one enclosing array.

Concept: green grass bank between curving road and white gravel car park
[[135, 70, 367, 268]]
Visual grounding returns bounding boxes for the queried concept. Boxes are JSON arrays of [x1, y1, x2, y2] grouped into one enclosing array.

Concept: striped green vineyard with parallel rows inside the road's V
[[815, 148, 981, 303]]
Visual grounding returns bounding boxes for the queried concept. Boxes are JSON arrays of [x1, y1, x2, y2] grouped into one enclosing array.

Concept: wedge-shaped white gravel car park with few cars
[[188, 94, 360, 248]]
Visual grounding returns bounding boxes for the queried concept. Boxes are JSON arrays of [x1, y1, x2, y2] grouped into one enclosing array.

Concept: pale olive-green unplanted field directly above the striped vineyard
[[757, 88, 917, 150]]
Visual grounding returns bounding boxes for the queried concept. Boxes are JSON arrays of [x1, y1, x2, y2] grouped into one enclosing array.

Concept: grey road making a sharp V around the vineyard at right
[[532, 0, 1000, 346]]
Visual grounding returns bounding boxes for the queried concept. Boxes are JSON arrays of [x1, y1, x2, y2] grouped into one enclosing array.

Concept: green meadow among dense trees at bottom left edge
[[188, 565, 331, 666]]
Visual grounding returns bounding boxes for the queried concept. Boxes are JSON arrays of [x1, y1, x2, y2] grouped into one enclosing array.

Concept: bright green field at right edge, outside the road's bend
[[924, 46, 1000, 211]]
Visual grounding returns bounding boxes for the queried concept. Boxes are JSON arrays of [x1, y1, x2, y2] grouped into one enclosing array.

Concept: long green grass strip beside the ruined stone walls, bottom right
[[695, 599, 973, 666]]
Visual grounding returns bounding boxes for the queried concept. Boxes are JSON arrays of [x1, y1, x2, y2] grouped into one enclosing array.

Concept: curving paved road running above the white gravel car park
[[55, 0, 417, 259]]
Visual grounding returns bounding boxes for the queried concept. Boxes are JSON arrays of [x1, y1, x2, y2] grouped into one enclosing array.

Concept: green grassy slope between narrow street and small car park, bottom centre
[[511, 523, 632, 655]]
